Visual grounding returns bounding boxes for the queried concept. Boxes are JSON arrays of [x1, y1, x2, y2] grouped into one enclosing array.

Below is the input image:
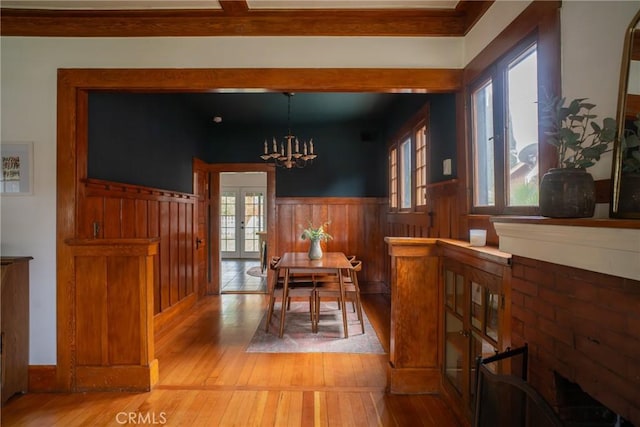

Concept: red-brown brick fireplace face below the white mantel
[[511, 255, 640, 426]]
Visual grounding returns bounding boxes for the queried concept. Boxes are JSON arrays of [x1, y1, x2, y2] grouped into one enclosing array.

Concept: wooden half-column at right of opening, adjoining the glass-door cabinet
[[384, 237, 440, 394]]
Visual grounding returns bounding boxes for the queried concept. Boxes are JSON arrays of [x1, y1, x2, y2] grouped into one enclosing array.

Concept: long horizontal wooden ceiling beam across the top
[[0, 1, 492, 37]]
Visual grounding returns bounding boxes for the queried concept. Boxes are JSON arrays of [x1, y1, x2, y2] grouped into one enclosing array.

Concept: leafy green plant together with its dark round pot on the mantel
[[540, 97, 616, 218]]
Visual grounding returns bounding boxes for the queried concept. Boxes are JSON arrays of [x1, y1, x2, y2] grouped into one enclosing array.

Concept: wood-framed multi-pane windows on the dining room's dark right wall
[[388, 103, 430, 212]]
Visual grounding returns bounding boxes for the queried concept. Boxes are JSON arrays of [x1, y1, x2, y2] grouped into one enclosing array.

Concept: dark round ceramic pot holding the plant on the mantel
[[540, 168, 596, 218]]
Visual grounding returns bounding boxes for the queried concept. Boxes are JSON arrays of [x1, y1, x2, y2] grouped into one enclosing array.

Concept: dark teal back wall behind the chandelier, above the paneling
[[205, 123, 386, 197]]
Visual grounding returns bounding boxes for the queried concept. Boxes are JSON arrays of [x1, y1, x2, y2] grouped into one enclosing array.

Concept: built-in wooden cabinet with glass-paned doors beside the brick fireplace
[[440, 242, 511, 417]]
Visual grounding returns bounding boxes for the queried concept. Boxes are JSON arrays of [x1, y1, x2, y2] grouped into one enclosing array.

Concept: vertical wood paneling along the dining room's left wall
[[78, 179, 196, 314]]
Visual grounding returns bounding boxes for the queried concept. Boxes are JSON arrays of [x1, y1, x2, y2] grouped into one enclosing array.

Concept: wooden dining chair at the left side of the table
[[265, 257, 315, 332]]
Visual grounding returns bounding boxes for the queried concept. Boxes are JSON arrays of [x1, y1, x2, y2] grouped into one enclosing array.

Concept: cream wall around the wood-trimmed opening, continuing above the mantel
[[0, 1, 637, 365]]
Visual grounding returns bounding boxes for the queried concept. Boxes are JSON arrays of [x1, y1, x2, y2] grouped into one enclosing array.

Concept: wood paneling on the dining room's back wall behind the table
[[274, 197, 386, 292]]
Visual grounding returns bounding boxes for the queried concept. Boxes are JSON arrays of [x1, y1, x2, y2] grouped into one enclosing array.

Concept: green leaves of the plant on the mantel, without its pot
[[541, 96, 616, 168]]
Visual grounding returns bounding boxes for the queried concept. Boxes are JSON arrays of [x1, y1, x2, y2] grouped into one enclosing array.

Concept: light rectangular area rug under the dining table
[[246, 302, 385, 354]]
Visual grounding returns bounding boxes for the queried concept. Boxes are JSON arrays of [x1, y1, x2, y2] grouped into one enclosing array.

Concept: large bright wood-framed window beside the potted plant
[[470, 40, 539, 214]]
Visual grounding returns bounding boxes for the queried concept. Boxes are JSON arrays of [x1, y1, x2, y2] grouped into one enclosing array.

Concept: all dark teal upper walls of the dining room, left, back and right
[[88, 93, 456, 197]]
